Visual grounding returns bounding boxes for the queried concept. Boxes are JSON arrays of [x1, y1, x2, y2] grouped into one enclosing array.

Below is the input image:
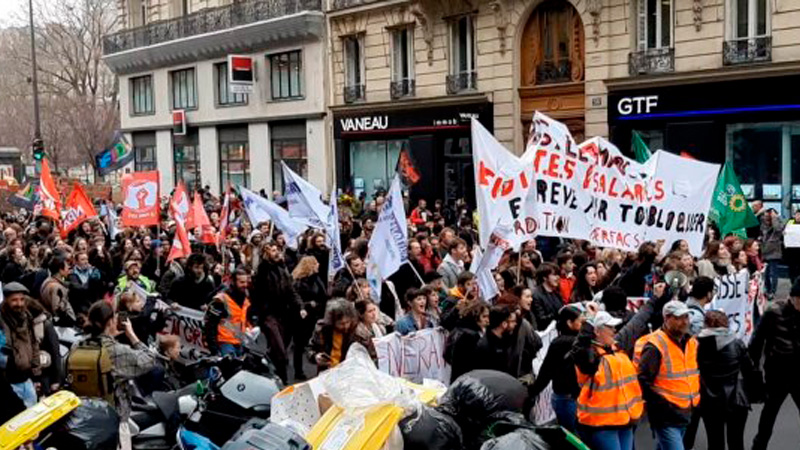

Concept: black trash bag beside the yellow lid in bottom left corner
[[47, 397, 119, 450]]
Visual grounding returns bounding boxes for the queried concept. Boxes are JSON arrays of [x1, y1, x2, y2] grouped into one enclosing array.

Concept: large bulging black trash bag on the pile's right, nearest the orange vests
[[439, 370, 528, 448]]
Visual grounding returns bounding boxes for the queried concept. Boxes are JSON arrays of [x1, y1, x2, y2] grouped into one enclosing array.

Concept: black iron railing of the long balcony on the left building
[[103, 0, 322, 55]]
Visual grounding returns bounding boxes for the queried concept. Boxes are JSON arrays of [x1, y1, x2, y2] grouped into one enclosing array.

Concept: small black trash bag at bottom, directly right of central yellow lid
[[400, 406, 463, 450]]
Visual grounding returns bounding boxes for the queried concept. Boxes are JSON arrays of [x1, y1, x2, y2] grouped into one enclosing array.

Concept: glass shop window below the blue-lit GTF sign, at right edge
[[726, 122, 800, 218]]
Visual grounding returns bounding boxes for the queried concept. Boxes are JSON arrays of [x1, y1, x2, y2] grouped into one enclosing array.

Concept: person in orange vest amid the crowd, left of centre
[[204, 269, 251, 356]]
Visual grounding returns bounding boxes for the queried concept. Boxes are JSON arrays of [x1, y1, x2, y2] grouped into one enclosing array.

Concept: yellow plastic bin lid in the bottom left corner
[[0, 391, 81, 450]]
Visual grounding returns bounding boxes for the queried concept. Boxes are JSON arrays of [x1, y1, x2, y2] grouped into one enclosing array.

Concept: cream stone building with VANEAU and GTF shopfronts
[[327, 0, 800, 209]]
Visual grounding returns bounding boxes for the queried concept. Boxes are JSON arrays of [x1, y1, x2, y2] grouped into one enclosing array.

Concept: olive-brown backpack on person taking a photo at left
[[67, 338, 115, 405]]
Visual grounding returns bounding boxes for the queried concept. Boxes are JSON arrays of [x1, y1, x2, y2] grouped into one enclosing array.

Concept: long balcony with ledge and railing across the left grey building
[[103, 0, 324, 74]]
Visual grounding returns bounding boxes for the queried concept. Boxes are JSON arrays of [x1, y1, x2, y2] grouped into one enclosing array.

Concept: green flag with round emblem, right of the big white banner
[[709, 162, 759, 237]]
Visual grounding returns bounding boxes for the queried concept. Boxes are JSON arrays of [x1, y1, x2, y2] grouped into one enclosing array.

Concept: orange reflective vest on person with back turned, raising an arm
[[575, 346, 644, 427]]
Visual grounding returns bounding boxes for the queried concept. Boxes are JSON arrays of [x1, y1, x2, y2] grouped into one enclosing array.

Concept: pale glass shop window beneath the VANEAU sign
[[350, 139, 408, 199]]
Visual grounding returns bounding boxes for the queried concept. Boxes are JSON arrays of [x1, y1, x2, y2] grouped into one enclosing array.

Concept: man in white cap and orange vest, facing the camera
[[633, 300, 700, 450]]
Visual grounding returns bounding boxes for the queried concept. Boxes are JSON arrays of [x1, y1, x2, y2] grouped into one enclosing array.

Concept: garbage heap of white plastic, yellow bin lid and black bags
[[272, 349, 588, 450]]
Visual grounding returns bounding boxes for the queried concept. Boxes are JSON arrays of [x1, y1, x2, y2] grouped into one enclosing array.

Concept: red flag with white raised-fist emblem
[[122, 170, 161, 227]]
